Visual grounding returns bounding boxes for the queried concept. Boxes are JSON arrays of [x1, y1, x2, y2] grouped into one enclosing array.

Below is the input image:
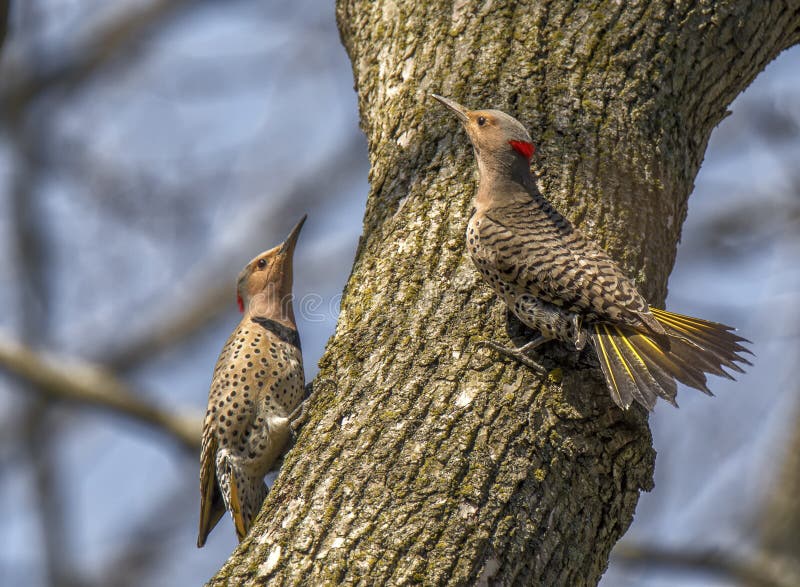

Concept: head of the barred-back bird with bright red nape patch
[[431, 94, 535, 176]]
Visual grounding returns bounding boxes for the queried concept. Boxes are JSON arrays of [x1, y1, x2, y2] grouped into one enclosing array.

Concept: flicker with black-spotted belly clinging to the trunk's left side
[[197, 216, 306, 547]]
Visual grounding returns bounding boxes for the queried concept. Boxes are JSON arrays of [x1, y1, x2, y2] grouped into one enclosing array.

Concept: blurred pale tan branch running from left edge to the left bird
[[0, 335, 200, 451]]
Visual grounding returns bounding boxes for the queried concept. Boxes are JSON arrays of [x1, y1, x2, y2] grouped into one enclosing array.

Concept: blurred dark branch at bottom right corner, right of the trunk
[[613, 542, 800, 587]]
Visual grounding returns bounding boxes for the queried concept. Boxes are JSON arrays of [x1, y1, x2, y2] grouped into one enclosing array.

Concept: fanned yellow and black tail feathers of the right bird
[[590, 308, 752, 410]]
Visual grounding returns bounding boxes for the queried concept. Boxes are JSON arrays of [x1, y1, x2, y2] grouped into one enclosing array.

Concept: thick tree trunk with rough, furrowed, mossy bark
[[211, 0, 800, 585]]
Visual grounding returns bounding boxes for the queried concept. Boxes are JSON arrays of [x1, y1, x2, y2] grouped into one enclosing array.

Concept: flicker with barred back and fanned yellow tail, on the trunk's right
[[433, 95, 750, 410]]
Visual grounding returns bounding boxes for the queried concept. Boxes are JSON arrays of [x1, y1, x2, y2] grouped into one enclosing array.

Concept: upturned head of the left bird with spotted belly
[[236, 216, 306, 324]]
